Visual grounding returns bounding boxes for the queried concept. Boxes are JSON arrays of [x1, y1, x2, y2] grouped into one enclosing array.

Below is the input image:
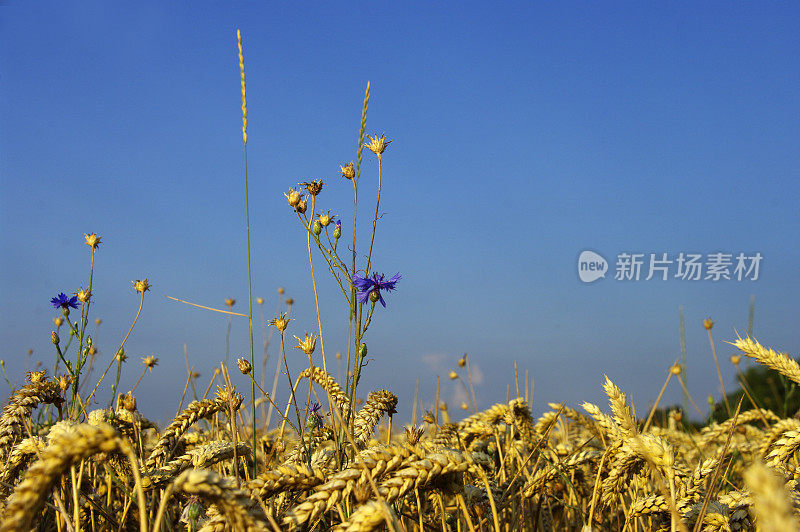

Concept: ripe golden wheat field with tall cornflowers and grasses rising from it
[[0, 33, 800, 532]]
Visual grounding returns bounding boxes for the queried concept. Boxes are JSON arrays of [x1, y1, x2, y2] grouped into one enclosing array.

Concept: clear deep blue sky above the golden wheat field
[[0, 1, 800, 419]]
